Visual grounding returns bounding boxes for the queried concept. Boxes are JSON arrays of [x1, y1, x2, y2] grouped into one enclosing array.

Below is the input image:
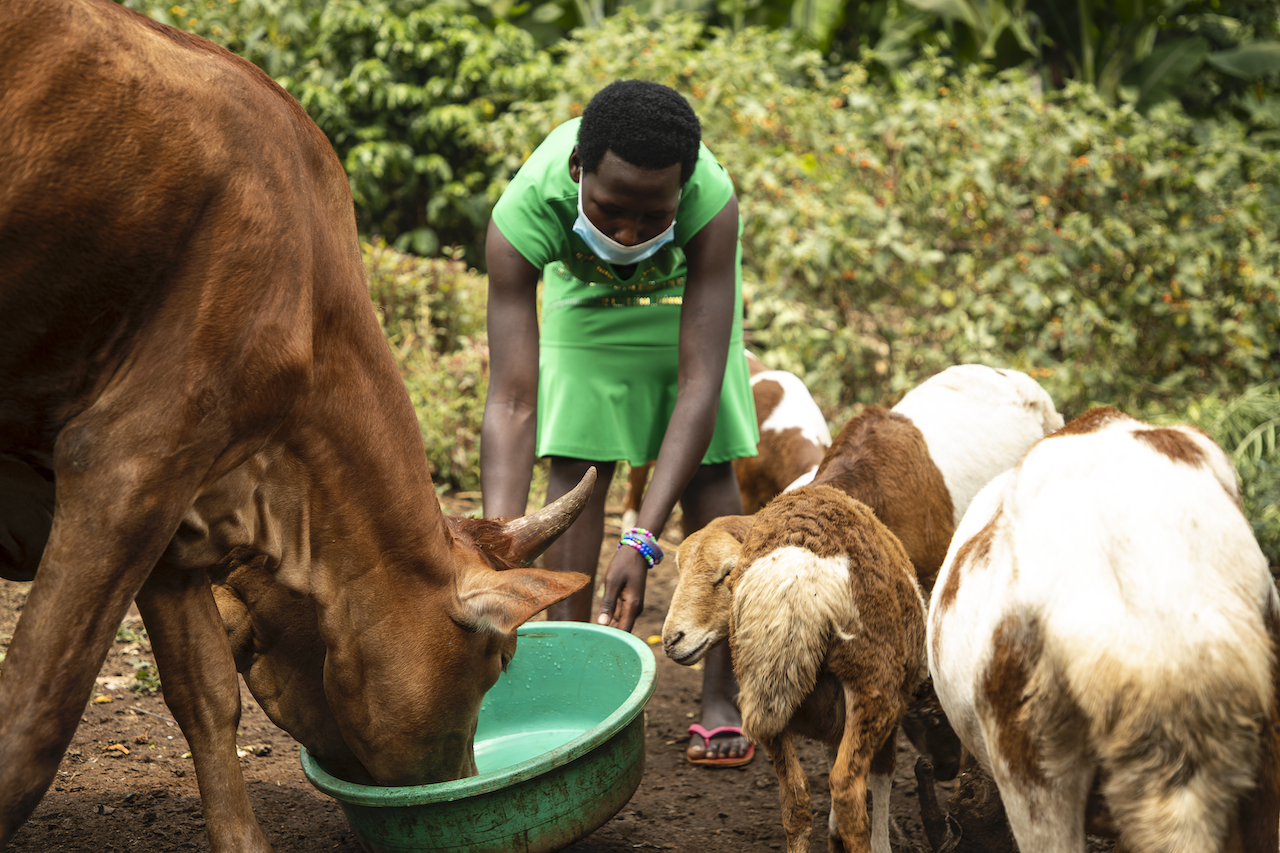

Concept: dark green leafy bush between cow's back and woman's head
[[123, 0, 550, 263]]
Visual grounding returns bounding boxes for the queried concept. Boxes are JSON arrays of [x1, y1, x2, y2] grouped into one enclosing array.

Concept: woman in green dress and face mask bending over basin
[[480, 81, 758, 766]]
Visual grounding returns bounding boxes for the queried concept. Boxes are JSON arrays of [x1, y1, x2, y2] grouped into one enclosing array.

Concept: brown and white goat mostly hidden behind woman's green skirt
[[622, 351, 831, 530]]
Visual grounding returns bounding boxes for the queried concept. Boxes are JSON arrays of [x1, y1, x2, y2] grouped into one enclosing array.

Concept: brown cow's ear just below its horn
[[454, 569, 590, 634]]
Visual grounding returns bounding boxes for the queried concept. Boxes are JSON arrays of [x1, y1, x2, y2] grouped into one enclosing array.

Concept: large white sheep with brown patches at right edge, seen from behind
[[929, 409, 1280, 853]]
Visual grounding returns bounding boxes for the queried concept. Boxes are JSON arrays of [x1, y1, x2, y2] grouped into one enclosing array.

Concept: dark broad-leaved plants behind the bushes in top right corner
[[773, 0, 1280, 123]]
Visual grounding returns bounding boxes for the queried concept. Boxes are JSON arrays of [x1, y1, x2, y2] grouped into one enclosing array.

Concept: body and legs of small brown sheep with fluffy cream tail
[[726, 485, 925, 853]]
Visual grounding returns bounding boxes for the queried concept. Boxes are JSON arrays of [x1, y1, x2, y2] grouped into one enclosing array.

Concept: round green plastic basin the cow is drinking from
[[302, 622, 657, 853]]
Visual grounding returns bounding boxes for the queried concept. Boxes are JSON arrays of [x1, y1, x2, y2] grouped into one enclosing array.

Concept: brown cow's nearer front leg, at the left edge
[[0, 410, 227, 848]]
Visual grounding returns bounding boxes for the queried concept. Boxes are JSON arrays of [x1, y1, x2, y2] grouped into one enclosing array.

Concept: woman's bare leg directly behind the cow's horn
[[543, 456, 614, 622]]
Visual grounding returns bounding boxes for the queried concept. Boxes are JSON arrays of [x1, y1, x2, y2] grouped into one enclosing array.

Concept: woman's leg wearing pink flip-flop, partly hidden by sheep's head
[[680, 462, 749, 760]]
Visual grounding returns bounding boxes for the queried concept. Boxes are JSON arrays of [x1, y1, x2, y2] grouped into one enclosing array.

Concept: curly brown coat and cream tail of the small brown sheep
[[728, 485, 925, 738]]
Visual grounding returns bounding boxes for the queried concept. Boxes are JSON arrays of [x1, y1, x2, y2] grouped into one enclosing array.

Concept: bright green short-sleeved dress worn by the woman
[[493, 119, 759, 465]]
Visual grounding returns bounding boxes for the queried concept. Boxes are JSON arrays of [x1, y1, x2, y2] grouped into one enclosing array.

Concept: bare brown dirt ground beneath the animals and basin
[[0, 484, 1106, 853]]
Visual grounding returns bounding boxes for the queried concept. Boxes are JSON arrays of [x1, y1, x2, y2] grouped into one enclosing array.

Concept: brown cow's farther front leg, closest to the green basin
[[137, 564, 271, 853]]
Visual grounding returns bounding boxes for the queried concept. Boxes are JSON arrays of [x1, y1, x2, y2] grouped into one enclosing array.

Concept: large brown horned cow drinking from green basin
[[0, 0, 591, 852]]
